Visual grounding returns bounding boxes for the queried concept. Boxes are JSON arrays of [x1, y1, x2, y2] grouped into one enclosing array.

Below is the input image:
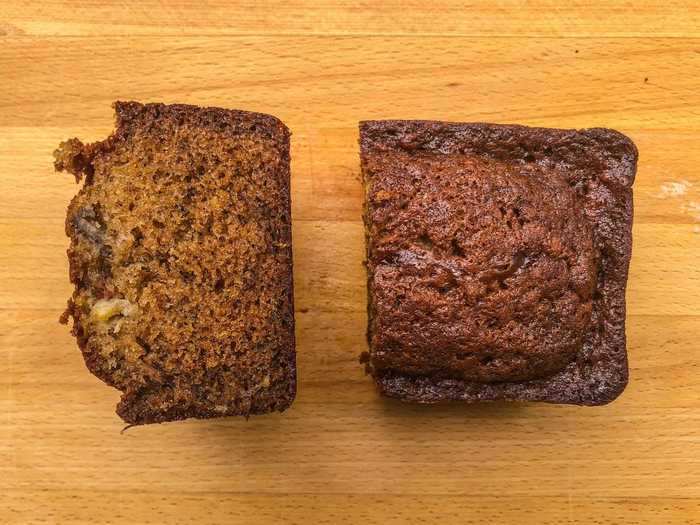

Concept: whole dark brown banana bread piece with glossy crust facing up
[[360, 121, 637, 405]]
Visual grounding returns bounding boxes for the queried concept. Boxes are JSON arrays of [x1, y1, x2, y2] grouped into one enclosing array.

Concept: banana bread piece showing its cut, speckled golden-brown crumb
[[55, 102, 296, 424]]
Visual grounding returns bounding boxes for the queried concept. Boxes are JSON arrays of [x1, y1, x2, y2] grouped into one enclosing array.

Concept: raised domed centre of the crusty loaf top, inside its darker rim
[[367, 147, 596, 381]]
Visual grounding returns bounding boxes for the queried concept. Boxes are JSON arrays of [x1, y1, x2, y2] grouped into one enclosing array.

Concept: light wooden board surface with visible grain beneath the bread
[[0, 0, 700, 524]]
